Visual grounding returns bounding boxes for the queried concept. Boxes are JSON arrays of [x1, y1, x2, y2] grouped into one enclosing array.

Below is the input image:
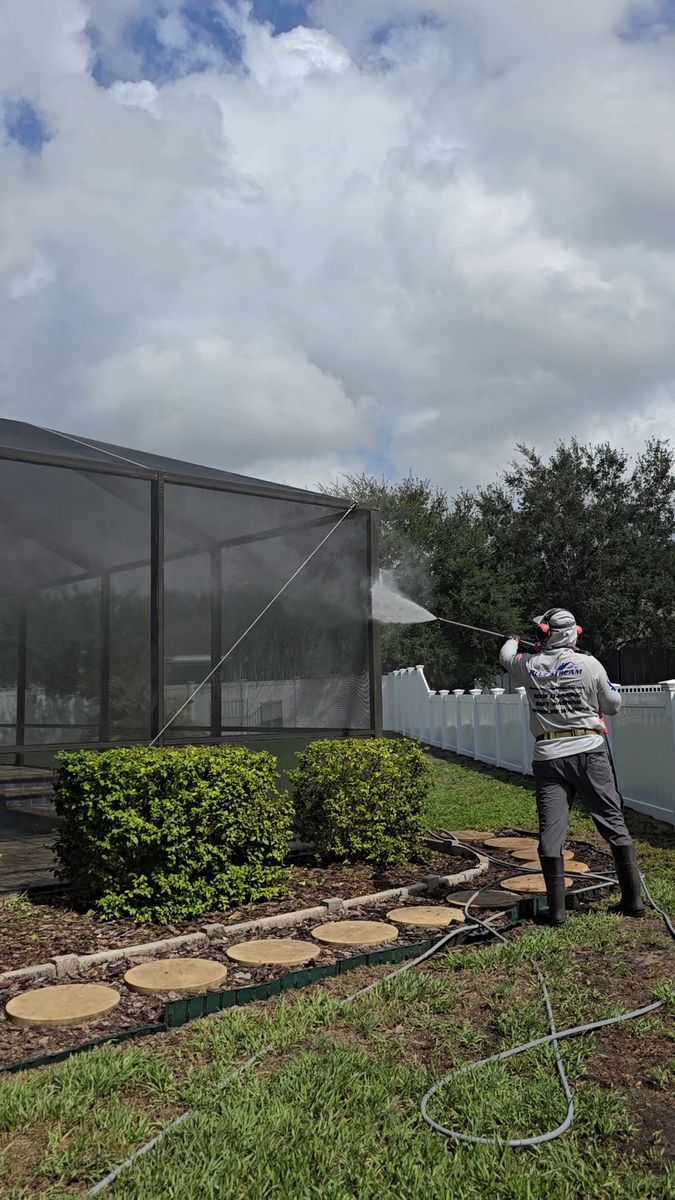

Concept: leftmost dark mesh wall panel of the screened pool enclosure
[[0, 460, 150, 746]]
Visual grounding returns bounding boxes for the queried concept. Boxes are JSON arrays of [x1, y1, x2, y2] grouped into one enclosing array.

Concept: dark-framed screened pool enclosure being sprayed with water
[[0, 420, 381, 770]]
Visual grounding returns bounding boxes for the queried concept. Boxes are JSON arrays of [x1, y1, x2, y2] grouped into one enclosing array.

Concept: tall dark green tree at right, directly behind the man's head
[[477, 439, 675, 658]]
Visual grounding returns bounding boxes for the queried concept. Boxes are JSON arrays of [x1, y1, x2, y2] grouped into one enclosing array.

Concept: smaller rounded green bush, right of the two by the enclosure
[[291, 738, 431, 865]]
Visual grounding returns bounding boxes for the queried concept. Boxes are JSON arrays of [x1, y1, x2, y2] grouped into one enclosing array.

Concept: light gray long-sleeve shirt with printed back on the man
[[500, 638, 621, 760]]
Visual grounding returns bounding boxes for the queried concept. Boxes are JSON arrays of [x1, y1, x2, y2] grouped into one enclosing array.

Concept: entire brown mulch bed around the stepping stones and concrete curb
[[0, 829, 608, 1067]]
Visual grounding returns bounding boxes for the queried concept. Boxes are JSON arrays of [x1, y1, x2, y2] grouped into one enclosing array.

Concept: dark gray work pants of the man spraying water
[[532, 746, 631, 858]]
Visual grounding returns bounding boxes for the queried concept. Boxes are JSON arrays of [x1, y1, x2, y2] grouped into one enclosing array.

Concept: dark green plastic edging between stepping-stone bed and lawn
[[0, 882, 614, 1075]]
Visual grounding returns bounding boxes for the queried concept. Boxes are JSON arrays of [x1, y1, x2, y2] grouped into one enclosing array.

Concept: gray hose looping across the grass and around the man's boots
[[419, 841, 675, 1147]]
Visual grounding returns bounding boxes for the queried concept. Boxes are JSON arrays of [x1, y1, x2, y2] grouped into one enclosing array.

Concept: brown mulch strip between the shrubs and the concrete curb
[[0, 850, 476, 971]]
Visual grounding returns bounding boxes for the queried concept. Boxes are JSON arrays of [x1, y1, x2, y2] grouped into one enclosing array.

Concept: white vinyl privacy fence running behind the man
[[382, 666, 675, 826]]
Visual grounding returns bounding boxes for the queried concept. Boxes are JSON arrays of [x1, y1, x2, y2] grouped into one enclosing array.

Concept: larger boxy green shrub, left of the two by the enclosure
[[55, 746, 293, 922]]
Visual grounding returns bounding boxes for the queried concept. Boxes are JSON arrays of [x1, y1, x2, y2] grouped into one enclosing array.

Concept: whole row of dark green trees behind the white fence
[[322, 439, 675, 688]]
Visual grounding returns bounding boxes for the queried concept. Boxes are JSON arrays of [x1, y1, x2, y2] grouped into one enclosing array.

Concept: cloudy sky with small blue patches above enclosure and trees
[[0, 0, 675, 492]]
